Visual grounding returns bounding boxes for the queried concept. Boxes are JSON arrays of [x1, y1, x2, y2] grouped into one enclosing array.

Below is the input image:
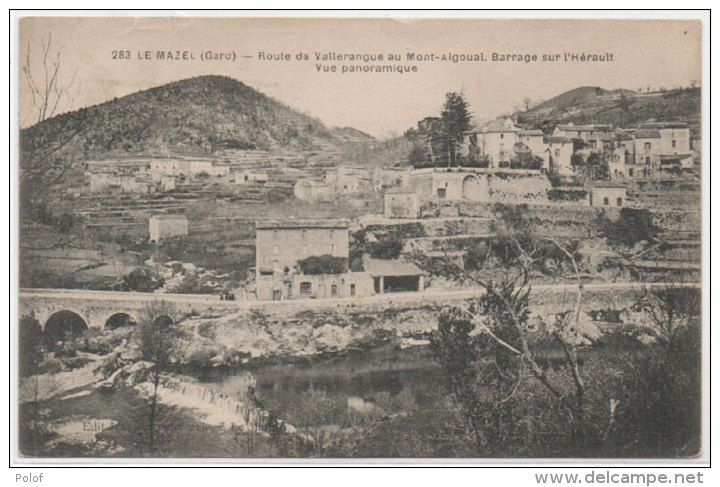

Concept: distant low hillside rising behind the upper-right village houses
[[514, 86, 701, 134]]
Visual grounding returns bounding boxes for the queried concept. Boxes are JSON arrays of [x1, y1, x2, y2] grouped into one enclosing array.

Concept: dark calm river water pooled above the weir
[[191, 345, 444, 421]]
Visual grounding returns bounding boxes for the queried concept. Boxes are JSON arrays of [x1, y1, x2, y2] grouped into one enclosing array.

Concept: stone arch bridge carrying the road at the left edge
[[19, 289, 238, 329]]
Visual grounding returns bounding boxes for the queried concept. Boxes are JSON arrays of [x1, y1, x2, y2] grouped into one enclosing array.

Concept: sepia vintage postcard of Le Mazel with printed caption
[[13, 13, 709, 463]]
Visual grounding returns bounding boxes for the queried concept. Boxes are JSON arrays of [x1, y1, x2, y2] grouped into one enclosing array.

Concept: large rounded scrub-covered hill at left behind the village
[[21, 76, 365, 162]]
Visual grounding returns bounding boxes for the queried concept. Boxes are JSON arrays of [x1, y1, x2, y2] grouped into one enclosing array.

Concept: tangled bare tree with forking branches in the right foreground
[[421, 203, 617, 454]]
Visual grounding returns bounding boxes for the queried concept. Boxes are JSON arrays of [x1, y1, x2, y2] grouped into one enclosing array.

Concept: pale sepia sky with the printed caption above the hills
[[18, 17, 701, 137]]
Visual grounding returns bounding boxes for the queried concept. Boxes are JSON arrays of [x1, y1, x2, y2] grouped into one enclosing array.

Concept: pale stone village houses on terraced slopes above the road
[[42, 117, 700, 300]]
